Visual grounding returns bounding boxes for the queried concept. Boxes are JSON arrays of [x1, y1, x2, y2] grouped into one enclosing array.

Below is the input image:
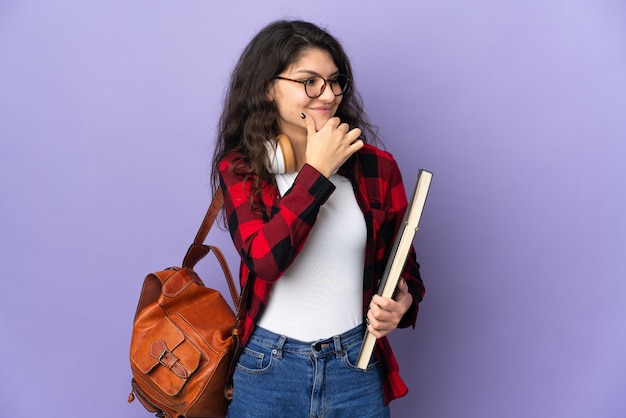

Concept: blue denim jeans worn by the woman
[[228, 326, 389, 418]]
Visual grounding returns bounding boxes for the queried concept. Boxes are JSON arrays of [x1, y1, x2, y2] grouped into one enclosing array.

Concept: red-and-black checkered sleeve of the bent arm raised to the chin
[[219, 158, 335, 283]]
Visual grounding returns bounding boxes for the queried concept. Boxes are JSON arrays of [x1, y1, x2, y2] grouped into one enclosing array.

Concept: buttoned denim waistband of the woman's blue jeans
[[250, 325, 365, 355]]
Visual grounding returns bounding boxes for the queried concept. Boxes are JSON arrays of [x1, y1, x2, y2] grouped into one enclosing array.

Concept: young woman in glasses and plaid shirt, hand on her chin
[[213, 21, 424, 418]]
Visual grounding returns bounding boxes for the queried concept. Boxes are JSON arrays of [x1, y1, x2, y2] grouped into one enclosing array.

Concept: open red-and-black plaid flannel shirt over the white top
[[219, 145, 424, 403]]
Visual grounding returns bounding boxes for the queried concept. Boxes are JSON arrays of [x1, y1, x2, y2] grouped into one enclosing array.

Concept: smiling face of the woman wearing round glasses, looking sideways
[[268, 49, 342, 141]]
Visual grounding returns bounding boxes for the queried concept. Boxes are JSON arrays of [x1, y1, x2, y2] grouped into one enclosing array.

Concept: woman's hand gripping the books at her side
[[367, 279, 413, 338]]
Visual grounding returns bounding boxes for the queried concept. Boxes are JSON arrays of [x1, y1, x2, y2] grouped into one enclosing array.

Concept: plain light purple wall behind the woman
[[0, 0, 626, 418]]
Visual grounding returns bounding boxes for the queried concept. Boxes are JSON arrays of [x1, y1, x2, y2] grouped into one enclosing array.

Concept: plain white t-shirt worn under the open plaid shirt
[[258, 173, 367, 342]]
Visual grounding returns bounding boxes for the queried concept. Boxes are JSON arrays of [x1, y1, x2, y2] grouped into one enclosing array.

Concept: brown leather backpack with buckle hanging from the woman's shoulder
[[129, 189, 248, 418]]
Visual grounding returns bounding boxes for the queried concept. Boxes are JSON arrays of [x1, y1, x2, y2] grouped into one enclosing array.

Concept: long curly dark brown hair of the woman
[[211, 20, 379, 211]]
